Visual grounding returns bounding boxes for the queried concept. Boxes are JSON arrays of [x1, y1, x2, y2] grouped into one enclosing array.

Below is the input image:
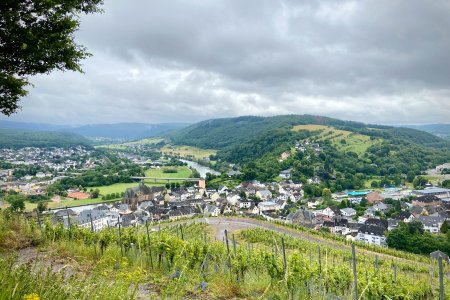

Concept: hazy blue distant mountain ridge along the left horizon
[[0, 120, 188, 141]]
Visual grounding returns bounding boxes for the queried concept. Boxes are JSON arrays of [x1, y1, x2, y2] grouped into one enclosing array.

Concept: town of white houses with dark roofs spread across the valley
[[0, 141, 450, 247]]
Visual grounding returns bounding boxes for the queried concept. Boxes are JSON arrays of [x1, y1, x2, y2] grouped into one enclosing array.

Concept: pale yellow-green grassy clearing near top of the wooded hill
[[292, 124, 382, 156]]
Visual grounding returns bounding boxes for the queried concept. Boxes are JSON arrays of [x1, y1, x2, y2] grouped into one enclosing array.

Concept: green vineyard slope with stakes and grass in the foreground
[[0, 214, 450, 299]]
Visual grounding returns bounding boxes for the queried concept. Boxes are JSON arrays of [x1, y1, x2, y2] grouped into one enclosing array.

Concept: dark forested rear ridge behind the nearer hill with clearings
[[169, 115, 448, 150]]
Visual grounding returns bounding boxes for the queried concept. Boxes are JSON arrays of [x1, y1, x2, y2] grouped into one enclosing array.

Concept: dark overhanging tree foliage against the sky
[[0, 0, 102, 115]]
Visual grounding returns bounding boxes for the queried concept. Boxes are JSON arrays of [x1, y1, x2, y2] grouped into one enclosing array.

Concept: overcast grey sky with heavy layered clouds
[[1, 0, 450, 124]]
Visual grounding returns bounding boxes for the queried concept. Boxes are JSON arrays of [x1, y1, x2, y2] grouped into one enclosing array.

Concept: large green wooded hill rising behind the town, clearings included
[[169, 115, 450, 191]]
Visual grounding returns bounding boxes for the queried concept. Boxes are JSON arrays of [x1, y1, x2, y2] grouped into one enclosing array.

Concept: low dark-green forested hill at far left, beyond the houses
[[0, 128, 91, 148]]
